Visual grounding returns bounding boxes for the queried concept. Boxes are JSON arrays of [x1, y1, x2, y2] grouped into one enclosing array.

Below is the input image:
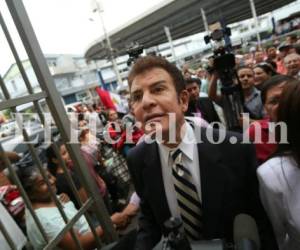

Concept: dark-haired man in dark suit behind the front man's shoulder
[[185, 78, 220, 123]]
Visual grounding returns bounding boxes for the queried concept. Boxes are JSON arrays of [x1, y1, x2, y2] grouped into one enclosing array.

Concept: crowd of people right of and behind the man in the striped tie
[[144, 36, 300, 249]]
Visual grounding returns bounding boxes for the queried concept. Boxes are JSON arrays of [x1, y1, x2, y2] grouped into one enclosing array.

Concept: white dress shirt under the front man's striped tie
[[158, 122, 202, 218]]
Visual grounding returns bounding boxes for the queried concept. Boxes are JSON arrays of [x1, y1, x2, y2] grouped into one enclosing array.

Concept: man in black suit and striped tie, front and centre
[[127, 56, 276, 250]]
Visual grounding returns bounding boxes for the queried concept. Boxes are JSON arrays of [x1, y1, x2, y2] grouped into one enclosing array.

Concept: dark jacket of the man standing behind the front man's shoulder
[[185, 97, 220, 123]]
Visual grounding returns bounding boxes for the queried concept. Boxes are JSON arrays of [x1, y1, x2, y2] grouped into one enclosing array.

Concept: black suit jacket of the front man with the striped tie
[[127, 128, 277, 250]]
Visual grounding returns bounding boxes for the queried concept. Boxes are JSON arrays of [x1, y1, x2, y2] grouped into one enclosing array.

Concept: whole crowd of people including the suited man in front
[[1, 33, 300, 250]]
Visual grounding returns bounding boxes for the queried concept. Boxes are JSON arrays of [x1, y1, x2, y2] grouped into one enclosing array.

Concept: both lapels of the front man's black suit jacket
[[142, 129, 226, 236]]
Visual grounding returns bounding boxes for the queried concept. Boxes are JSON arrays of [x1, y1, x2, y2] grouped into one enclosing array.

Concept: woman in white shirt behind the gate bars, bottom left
[[17, 166, 124, 250]]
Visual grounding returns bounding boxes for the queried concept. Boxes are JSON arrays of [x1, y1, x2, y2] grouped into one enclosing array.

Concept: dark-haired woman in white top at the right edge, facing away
[[257, 80, 300, 250]]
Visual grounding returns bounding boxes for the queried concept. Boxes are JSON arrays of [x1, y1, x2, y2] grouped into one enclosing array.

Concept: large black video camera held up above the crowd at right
[[204, 23, 243, 130]]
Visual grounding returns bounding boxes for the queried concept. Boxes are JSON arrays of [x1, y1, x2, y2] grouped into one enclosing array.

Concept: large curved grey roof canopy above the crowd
[[85, 0, 294, 60]]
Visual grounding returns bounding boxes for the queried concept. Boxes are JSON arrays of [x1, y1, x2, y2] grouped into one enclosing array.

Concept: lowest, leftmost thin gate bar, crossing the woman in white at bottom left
[[0, 143, 49, 242]]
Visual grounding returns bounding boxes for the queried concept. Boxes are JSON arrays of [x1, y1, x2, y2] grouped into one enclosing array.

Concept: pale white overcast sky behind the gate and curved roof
[[0, 0, 165, 75]]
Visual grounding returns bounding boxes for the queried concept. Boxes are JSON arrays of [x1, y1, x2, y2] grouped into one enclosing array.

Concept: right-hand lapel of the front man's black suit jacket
[[198, 133, 226, 235]]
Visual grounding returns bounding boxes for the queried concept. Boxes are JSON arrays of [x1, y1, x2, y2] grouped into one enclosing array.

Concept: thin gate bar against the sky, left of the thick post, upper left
[[0, 12, 44, 124]]
